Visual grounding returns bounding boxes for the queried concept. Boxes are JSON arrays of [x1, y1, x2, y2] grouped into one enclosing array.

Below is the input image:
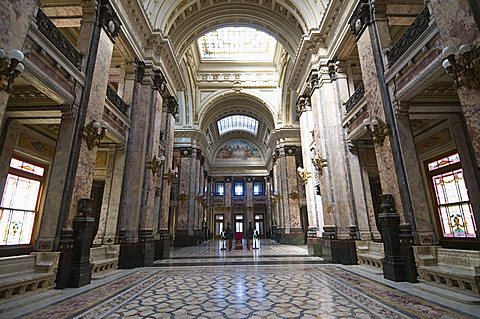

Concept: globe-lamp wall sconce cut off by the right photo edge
[[442, 44, 480, 90]]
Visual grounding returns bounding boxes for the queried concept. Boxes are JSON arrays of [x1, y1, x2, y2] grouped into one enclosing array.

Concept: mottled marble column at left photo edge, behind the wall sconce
[[0, 0, 39, 131]]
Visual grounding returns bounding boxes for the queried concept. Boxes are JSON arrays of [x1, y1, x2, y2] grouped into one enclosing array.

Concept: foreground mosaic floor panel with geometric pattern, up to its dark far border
[[20, 265, 469, 319]]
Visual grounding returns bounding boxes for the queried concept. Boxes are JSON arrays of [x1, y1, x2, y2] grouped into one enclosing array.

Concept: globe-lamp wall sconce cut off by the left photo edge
[[0, 49, 25, 93]]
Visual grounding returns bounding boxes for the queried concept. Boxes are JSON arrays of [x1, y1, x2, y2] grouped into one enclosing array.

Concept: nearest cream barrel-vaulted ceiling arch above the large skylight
[[142, 0, 330, 56]]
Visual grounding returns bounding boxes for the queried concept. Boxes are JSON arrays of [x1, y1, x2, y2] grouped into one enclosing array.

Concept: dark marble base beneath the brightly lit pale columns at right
[[320, 238, 357, 265]]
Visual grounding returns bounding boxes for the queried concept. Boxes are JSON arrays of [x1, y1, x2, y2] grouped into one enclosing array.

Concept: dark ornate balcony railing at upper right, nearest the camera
[[387, 8, 430, 66]]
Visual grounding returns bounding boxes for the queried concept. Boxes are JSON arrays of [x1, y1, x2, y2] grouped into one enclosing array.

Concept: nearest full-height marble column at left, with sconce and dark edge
[[54, 1, 120, 288]]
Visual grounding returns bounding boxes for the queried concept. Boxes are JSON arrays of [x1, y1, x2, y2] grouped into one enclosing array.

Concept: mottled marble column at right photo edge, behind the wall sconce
[[429, 0, 480, 169]]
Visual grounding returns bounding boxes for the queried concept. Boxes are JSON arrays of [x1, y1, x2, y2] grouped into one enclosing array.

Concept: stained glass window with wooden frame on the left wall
[[0, 158, 45, 245]]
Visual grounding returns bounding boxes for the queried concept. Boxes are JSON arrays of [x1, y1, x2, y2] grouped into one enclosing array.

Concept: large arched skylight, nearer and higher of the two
[[198, 27, 277, 62]]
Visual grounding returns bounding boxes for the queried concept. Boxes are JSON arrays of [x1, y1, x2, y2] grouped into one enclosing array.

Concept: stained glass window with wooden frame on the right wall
[[428, 154, 476, 238]]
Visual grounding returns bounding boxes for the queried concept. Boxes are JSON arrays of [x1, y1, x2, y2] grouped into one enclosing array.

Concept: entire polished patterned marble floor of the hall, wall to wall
[[0, 244, 480, 319]]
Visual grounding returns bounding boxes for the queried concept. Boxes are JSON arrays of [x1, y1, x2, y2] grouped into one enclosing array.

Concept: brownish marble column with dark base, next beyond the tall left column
[[118, 62, 154, 268]]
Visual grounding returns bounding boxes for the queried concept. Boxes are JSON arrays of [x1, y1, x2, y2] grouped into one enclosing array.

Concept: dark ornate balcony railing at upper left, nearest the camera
[[37, 10, 83, 69]]
